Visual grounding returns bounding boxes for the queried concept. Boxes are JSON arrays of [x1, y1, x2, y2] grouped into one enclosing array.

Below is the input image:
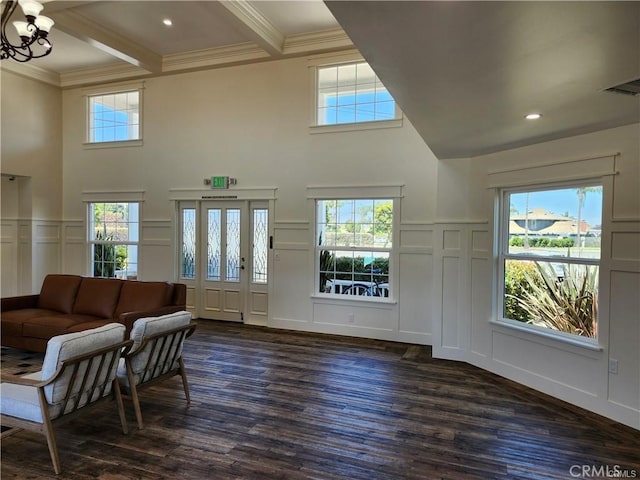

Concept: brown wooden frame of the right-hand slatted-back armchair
[[122, 322, 197, 430]]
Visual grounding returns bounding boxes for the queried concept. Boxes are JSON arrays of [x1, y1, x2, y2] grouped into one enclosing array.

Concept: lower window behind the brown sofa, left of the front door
[[88, 202, 140, 279]]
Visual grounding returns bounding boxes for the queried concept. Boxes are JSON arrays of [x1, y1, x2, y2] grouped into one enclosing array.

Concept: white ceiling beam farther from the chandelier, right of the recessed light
[[219, 0, 285, 57]]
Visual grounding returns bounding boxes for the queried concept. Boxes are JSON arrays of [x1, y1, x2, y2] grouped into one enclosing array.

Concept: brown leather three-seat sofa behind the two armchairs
[[0, 274, 187, 352]]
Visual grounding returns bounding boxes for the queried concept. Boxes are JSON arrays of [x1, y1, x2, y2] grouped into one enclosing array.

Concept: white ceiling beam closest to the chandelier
[[51, 10, 162, 73]]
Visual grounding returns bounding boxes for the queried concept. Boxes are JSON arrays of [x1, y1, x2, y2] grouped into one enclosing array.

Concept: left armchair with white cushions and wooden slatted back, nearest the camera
[[0, 323, 132, 474]]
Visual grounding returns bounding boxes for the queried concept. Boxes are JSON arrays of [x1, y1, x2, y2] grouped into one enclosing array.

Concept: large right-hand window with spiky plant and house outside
[[498, 181, 603, 339]]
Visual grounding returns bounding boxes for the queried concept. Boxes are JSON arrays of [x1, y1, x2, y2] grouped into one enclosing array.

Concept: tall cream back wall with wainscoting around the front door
[[58, 58, 437, 343]]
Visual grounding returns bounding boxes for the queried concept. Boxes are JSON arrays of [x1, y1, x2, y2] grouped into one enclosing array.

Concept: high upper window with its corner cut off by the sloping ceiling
[[316, 61, 400, 125]]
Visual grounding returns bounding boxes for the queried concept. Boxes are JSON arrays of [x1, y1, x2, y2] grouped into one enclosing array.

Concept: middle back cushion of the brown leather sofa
[[73, 277, 122, 318]]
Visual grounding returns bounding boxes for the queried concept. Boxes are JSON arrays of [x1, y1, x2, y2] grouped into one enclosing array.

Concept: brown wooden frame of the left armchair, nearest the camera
[[0, 340, 133, 474]]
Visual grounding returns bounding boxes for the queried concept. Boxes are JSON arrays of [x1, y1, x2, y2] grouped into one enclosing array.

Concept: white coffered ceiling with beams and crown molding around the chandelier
[[3, 0, 353, 84]]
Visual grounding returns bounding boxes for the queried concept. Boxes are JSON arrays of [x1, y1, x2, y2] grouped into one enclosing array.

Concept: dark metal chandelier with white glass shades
[[0, 0, 53, 62]]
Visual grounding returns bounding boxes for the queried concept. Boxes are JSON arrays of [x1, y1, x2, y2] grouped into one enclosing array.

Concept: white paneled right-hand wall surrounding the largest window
[[433, 125, 640, 428]]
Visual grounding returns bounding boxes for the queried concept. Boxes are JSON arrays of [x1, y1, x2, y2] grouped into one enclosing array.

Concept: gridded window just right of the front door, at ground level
[[316, 198, 394, 299]]
